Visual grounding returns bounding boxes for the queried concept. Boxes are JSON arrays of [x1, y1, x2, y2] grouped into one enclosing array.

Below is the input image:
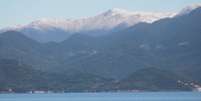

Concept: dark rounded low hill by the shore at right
[[119, 68, 192, 91]]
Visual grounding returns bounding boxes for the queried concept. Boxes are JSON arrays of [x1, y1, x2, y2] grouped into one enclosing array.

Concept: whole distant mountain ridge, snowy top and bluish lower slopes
[[2, 8, 175, 42]]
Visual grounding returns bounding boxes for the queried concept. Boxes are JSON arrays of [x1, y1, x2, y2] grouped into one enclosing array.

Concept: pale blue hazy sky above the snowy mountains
[[0, 0, 201, 28]]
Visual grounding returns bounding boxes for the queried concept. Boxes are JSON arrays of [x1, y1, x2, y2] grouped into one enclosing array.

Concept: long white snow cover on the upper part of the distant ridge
[[16, 8, 173, 32]]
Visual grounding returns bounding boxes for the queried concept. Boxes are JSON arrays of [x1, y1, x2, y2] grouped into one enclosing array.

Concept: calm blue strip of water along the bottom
[[0, 92, 201, 101]]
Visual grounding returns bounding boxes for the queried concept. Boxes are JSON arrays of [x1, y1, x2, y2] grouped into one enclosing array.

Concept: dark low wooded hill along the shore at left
[[0, 59, 109, 92]]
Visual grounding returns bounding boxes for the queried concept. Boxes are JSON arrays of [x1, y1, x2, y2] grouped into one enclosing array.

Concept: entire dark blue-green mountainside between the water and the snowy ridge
[[0, 8, 201, 91]]
